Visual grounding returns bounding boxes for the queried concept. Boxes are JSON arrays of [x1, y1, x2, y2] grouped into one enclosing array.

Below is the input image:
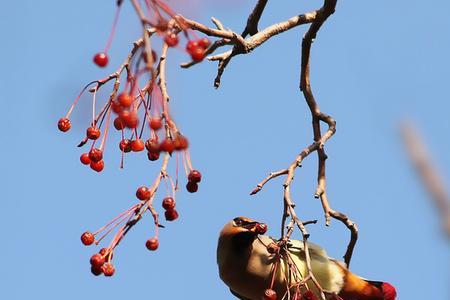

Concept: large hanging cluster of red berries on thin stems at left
[[58, 0, 211, 276]]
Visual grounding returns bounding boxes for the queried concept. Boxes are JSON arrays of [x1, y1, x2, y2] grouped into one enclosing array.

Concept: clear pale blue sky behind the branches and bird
[[0, 0, 450, 299]]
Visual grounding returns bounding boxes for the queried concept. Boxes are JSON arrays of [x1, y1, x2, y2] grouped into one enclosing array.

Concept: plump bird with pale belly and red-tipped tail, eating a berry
[[217, 217, 397, 300]]
